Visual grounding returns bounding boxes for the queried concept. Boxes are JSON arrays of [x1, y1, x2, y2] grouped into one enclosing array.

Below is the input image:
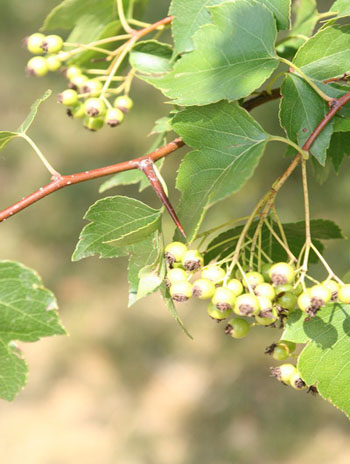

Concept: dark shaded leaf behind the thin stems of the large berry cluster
[[205, 219, 344, 264]]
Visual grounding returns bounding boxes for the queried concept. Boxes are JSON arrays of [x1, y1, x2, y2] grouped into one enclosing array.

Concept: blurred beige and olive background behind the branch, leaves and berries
[[0, 0, 350, 464]]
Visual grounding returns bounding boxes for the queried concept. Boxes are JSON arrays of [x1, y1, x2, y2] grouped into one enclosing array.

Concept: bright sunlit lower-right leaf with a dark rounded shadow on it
[[283, 303, 350, 417]]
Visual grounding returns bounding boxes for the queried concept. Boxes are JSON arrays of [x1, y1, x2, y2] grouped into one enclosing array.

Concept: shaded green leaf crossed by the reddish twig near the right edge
[[280, 74, 333, 166]]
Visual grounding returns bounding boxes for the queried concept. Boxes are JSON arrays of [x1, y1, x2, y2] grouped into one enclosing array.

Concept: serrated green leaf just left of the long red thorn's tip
[[72, 196, 161, 261]]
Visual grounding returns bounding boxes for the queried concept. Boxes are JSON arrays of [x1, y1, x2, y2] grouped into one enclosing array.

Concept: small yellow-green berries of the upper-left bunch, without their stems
[[26, 33, 133, 131]]
